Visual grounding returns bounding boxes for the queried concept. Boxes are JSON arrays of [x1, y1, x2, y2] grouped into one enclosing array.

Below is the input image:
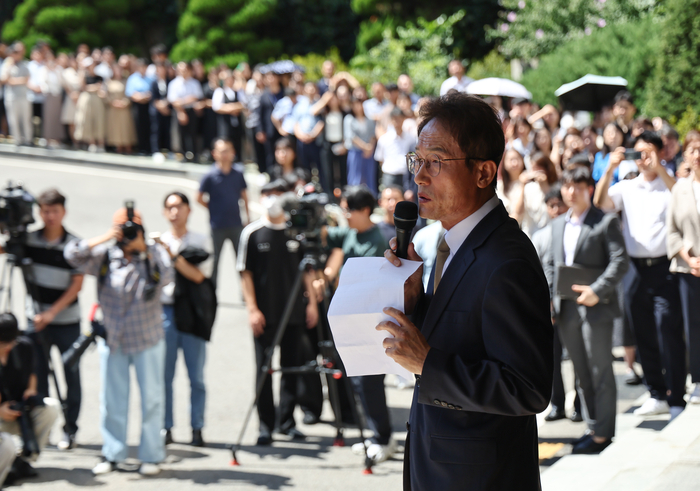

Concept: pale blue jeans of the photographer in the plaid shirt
[[99, 340, 165, 464]]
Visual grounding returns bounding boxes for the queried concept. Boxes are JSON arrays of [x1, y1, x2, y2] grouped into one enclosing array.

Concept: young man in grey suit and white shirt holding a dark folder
[[544, 167, 628, 454]]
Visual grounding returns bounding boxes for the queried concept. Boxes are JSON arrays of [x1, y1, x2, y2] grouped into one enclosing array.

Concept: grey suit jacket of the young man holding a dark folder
[[544, 206, 629, 324]]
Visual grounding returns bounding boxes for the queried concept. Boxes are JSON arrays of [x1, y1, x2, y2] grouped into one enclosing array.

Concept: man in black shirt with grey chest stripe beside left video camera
[[0, 189, 83, 450]]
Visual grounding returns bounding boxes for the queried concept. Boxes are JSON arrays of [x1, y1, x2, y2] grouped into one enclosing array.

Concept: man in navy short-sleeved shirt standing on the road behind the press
[[197, 137, 250, 284]]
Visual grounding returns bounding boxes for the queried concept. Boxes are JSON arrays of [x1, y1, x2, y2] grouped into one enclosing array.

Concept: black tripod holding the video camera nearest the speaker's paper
[[230, 239, 374, 474]]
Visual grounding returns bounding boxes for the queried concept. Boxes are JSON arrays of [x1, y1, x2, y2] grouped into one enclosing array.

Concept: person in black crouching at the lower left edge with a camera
[[0, 313, 60, 479]]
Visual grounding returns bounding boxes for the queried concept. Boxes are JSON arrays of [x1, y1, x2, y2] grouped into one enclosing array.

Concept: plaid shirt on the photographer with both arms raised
[[64, 240, 174, 354]]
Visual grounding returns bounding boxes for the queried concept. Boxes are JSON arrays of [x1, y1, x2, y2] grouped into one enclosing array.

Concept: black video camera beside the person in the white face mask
[[282, 184, 330, 241]]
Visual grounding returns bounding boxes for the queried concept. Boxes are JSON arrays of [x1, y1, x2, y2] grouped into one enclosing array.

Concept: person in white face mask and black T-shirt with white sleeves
[[237, 180, 318, 445]]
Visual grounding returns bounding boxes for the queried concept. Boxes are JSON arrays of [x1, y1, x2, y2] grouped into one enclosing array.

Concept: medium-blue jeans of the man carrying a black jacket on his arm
[[163, 305, 207, 430]]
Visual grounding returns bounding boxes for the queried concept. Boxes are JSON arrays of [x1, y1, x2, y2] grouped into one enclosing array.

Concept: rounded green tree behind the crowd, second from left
[[171, 0, 283, 66]]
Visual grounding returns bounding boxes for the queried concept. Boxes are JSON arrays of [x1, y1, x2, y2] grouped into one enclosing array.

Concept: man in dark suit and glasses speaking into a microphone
[[377, 94, 552, 491]]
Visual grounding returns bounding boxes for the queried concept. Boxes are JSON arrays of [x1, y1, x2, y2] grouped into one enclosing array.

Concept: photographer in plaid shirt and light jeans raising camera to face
[[65, 201, 174, 476]]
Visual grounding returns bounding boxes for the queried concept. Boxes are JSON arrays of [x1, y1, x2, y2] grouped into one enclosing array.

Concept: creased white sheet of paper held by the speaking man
[[328, 257, 423, 378]]
